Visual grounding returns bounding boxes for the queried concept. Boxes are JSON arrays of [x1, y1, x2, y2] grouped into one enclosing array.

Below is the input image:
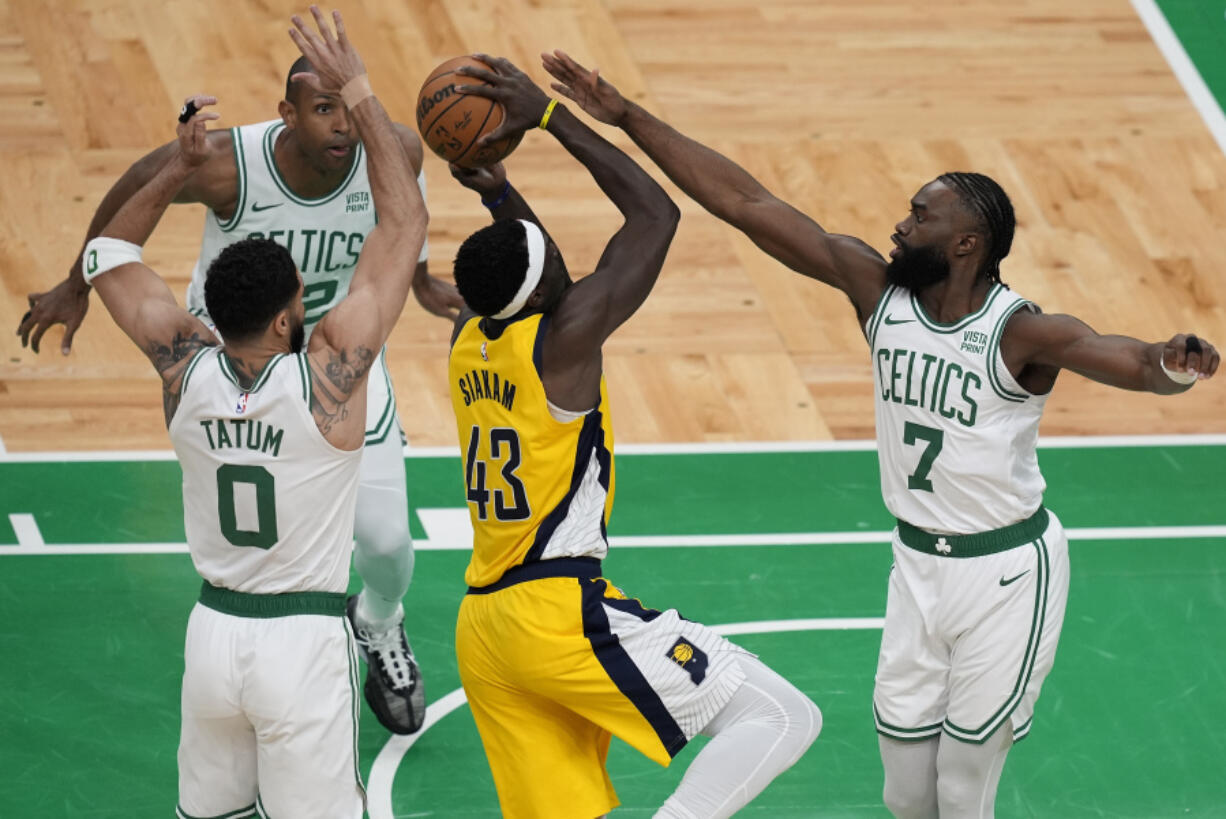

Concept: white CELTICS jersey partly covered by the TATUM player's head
[[188, 119, 375, 337]]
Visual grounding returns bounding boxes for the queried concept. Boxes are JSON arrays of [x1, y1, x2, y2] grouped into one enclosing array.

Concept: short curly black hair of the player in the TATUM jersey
[[205, 239, 298, 341]]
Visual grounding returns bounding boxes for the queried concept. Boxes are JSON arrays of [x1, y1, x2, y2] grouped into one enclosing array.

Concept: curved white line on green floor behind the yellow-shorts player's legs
[[367, 617, 885, 819]]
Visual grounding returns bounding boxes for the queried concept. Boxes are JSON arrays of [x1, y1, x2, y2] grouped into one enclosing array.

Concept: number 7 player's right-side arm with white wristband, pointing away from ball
[[1002, 310, 1221, 395]]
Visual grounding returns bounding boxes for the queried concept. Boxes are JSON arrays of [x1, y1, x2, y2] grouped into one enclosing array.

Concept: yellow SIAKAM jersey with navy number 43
[[447, 314, 613, 586]]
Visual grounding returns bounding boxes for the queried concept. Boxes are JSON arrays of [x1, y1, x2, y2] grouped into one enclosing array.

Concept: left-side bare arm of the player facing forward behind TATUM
[[17, 121, 238, 356]]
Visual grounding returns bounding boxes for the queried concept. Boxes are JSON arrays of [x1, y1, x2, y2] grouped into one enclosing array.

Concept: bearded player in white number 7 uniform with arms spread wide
[[543, 51, 1219, 819]]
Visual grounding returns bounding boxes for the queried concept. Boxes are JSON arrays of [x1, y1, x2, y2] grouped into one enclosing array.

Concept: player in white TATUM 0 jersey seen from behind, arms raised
[[85, 6, 427, 819]]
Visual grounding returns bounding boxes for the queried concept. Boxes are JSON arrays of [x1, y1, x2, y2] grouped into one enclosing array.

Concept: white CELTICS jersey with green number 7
[[866, 284, 1047, 535]]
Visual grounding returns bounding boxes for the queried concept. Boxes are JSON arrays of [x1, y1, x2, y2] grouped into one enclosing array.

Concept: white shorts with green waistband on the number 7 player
[[873, 509, 1069, 743]]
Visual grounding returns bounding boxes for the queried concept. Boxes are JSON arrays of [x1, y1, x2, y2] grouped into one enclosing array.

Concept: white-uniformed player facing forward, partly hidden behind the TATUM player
[[18, 19, 462, 733]]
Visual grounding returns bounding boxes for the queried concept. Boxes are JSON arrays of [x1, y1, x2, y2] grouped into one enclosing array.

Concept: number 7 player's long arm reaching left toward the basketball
[[541, 50, 885, 321]]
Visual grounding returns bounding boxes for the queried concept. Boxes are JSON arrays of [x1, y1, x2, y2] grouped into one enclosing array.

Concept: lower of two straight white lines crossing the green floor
[[0, 526, 1226, 557]]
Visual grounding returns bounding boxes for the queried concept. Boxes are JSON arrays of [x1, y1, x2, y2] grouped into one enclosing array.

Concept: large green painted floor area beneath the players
[[0, 443, 1226, 819]]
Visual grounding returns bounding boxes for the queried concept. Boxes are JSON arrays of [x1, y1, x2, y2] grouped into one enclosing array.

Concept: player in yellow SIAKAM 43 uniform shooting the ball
[[449, 56, 821, 819]]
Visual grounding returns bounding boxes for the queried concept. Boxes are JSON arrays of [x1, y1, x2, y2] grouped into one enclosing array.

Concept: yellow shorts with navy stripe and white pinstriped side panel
[[456, 558, 745, 819]]
